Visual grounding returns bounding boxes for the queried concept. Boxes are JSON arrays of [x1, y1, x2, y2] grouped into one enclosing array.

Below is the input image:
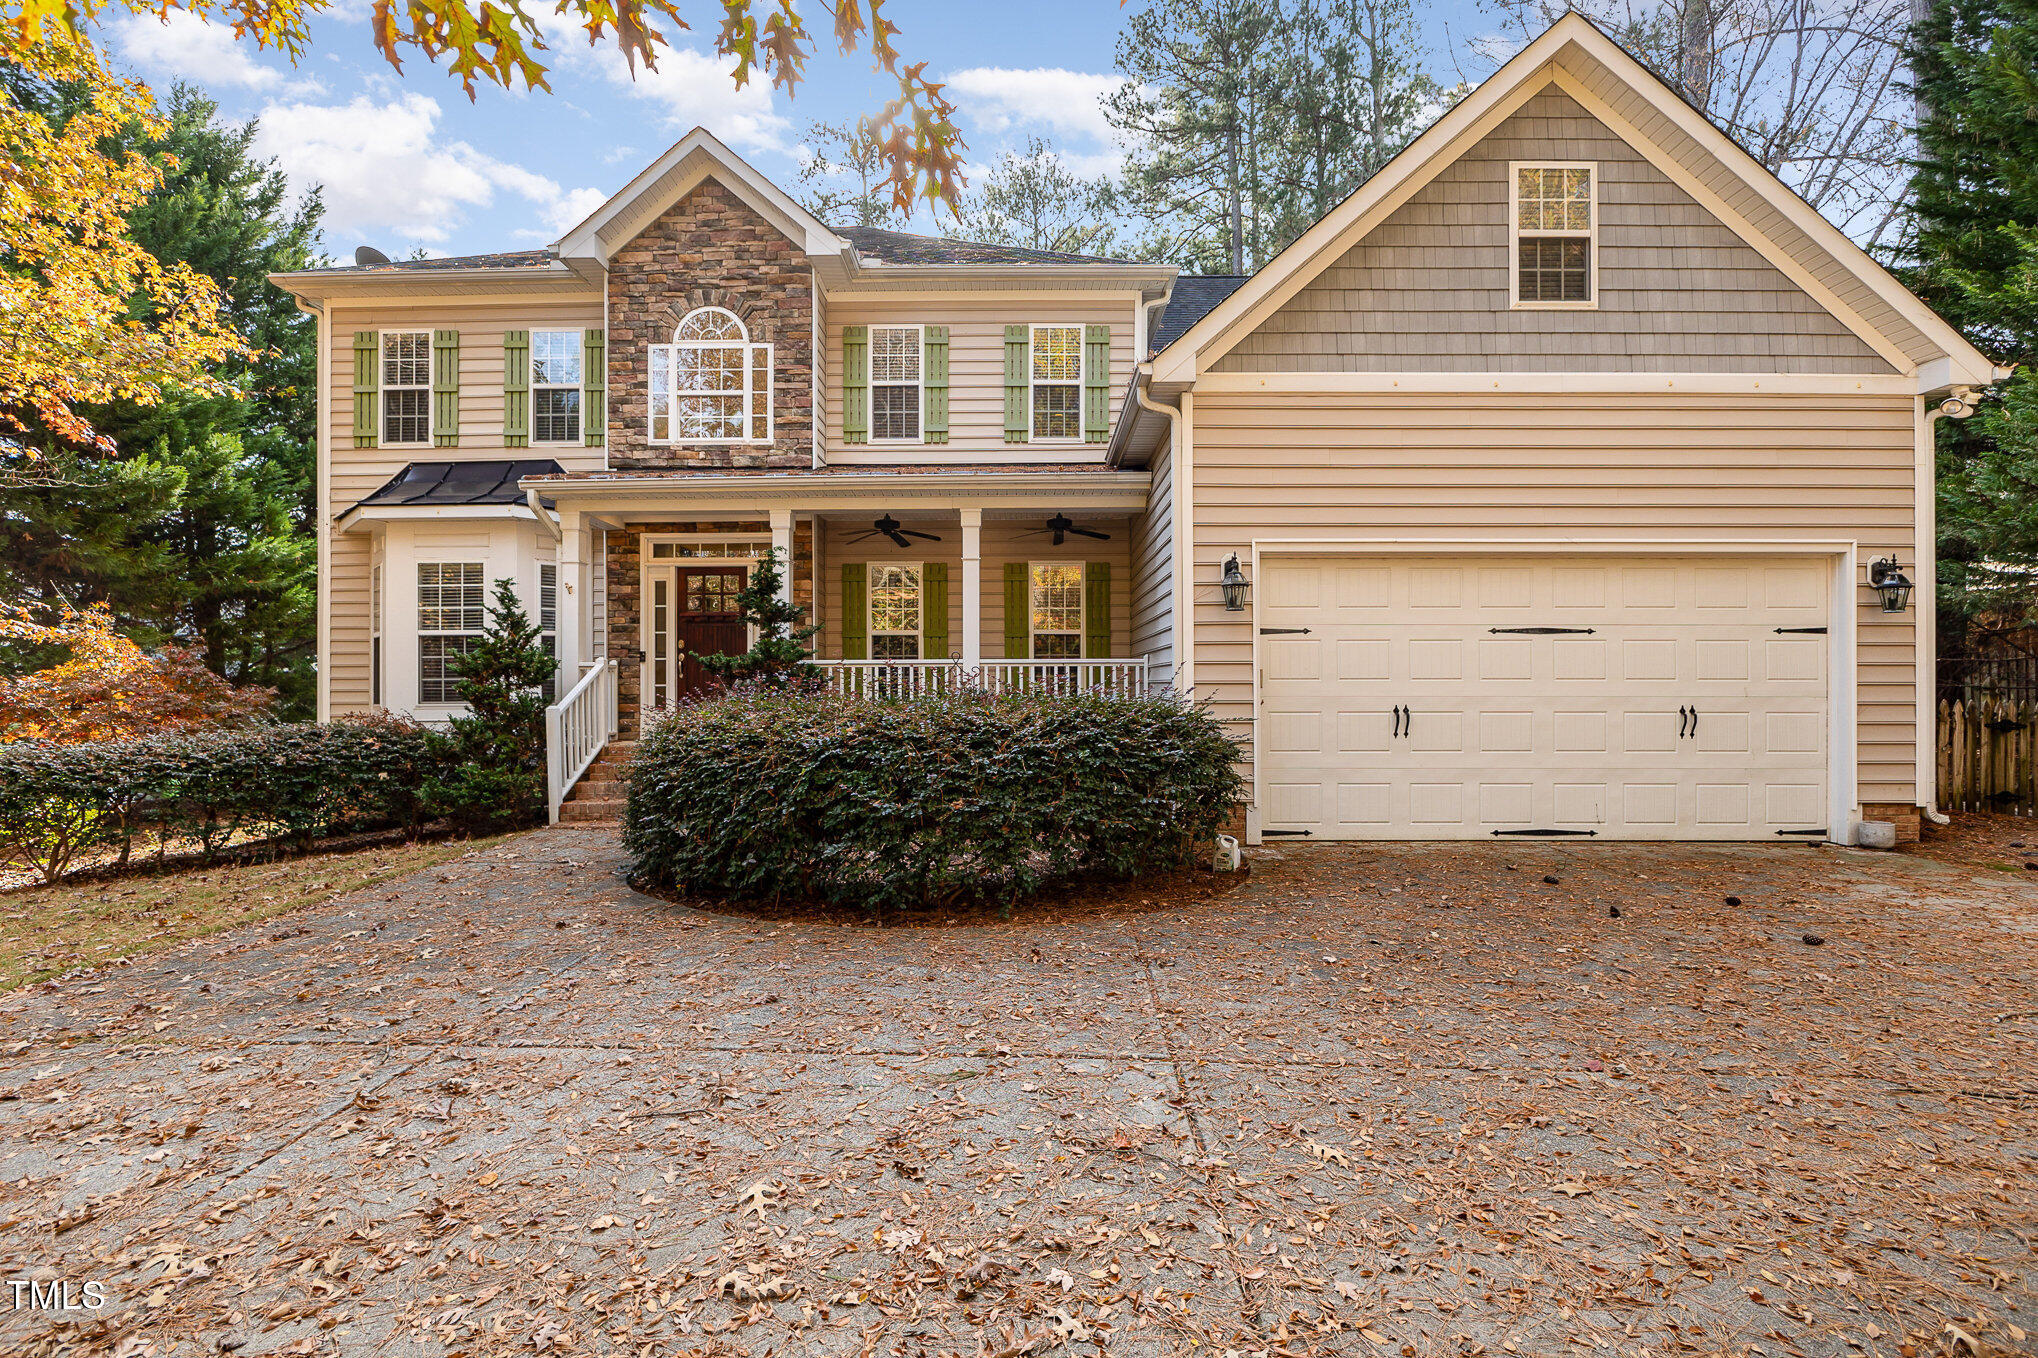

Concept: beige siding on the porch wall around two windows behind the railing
[[821, 508, 1137, 661]]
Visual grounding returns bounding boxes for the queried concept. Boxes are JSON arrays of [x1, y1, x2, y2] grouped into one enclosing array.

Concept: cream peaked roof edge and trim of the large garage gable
[[1154, 10, 1997, 391]]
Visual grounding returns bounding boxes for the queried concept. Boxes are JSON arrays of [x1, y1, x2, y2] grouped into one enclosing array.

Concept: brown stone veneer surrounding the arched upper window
[[609, 179, 815, 471]]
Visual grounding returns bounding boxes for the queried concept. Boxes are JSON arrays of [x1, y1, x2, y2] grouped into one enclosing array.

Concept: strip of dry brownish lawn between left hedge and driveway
[[0, 840, 509, 991]]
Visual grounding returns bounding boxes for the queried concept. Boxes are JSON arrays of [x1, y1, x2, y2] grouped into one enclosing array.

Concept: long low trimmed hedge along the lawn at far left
[[0, 718, 438, 881]]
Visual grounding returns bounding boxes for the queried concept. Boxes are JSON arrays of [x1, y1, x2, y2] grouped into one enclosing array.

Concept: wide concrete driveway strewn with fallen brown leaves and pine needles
[[0, 830, 2038, 1356]]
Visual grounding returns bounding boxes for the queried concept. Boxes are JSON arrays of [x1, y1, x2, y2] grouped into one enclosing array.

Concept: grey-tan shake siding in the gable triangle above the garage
[[1217, 88, 1893, 373]]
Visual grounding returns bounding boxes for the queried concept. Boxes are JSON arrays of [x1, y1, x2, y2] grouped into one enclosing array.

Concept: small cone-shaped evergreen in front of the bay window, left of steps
[[424, 579, 554, 834]]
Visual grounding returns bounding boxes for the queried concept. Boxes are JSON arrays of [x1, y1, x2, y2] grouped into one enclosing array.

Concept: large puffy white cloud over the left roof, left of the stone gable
[[255, 92, 605, 249]]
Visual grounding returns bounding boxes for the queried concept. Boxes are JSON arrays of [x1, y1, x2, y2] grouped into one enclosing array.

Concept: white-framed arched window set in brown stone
[[650, 306, 770, 442]]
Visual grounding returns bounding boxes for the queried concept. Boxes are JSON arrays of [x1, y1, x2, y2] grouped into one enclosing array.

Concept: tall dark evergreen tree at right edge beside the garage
[[1906, 0, 2038, 628]]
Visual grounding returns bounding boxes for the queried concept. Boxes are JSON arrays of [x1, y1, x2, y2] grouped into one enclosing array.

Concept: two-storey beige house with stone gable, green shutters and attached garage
[[275, 14, 1997, 840]]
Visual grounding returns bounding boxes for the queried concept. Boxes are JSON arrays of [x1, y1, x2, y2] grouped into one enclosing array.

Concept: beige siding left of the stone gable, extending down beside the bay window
[[326, 292, 603, 714]]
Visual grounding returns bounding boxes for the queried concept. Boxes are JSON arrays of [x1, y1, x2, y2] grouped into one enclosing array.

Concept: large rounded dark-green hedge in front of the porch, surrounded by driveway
[[624, 689, 1243, 911]]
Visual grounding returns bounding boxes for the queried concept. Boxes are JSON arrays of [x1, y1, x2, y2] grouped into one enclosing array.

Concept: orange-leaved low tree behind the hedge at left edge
[[0, 608, 275, 744]]
